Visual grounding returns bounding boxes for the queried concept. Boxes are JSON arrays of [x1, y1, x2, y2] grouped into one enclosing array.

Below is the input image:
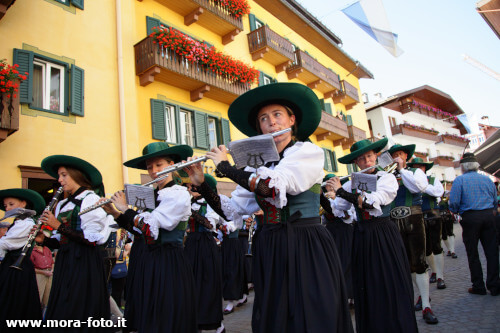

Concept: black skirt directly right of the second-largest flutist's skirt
[[184, 232, 222, 330]]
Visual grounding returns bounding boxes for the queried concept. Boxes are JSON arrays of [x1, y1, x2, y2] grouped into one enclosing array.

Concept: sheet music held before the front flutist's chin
[[228, 134, 279, 169]]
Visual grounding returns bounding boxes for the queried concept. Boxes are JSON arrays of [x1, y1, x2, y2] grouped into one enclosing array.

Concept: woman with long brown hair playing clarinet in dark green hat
[[42, 155, 113, 330]]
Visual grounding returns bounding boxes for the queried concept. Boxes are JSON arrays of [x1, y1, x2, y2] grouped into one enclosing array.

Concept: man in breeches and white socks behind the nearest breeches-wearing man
[[408, 157, 446, 289]]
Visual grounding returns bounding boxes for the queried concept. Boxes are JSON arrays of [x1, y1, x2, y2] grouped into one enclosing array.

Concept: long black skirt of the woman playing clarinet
[[45, 241, 110, 332]]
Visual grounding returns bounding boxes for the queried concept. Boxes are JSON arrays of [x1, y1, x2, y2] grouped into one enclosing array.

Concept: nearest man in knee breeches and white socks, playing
[[389, 144, 438, 324]]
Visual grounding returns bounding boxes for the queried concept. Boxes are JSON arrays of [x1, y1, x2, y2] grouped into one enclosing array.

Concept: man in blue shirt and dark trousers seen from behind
[[449, 153, 500, 296]]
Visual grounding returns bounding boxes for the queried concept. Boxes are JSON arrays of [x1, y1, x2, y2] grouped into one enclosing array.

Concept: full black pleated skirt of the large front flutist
[[252, 218, 353, 333]]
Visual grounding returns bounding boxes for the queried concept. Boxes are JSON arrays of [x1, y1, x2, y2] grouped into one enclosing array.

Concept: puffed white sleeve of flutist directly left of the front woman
[[139, 185, 191, 239]]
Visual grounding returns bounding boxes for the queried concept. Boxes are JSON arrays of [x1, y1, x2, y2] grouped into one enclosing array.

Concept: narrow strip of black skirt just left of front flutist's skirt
[[221, 237, 248, 301]]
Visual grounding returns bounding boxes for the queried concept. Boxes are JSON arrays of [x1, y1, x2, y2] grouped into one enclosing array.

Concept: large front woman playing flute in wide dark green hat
[[185, 83, 352, 332]]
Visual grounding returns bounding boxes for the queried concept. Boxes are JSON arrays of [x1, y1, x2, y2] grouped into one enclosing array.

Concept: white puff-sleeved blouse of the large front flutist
[[220, 142, 325, 225]]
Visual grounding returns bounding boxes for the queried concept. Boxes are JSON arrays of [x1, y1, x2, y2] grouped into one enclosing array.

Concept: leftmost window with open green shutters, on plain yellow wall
[[14, 49, 85, 116]]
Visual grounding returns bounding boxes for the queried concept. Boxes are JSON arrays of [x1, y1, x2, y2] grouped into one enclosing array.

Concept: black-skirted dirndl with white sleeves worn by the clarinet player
[[44, 191, 111, 332]]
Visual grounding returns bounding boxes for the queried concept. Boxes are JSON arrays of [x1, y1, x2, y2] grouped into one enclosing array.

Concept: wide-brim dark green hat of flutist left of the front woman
[[123, 142, 193, 170]]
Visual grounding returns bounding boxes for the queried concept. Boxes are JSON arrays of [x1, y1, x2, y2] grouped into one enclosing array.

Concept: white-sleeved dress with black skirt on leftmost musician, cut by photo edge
[[0, 218, 42, 331]]
